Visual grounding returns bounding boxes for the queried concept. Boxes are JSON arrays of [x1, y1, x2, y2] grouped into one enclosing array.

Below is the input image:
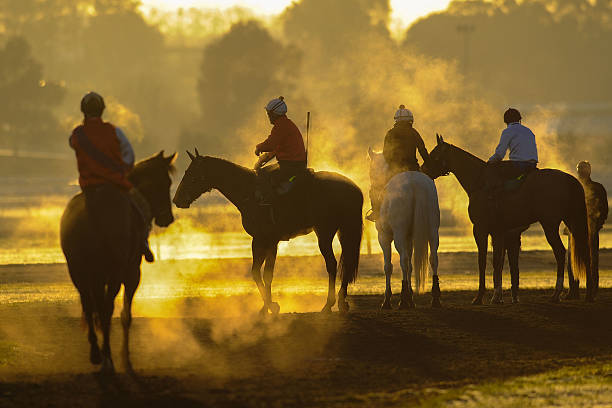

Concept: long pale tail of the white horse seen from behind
[[412, 180, 439, 293]]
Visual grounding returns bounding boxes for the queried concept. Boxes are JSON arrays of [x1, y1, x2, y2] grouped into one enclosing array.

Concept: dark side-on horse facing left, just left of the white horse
[[173, 150, 363, 314]]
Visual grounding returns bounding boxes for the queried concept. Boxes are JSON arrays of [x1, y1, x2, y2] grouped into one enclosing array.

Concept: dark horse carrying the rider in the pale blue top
[[424, 135, 595, 304]]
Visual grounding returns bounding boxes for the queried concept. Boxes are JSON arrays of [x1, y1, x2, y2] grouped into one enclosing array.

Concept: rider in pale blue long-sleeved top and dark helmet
[[487, 108, 538, 189]]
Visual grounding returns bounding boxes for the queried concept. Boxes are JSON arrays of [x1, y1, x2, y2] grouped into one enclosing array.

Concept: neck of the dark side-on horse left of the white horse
[[207, 158, 255, 211]]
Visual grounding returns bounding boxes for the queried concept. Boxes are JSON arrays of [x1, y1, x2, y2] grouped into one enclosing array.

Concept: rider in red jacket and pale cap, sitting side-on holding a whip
[[255, 96, 306, 194]]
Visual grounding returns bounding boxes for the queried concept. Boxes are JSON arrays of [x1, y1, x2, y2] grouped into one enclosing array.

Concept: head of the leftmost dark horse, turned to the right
[[129, 150, 177, 227]]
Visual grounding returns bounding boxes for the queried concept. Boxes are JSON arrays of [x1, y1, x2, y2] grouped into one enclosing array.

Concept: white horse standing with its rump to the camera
[[368, 148, 440, 309]]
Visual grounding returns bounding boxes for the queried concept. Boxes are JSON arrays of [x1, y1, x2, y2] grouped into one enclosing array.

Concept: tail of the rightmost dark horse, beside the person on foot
[[563, 179, 591, 289]]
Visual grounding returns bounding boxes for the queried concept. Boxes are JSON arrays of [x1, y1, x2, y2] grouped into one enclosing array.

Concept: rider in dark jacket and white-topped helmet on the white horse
[[366, 105, 429, 222]]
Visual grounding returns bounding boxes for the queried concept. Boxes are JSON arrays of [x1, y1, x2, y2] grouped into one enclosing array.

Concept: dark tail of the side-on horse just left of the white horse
[[338, 190, 363, 284]]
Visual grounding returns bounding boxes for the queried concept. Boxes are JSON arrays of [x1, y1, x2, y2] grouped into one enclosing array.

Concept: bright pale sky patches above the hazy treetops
[[142, 0, 450, 26]]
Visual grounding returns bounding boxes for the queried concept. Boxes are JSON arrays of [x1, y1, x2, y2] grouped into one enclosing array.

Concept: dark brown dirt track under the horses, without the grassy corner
[[0, 289, 612, 407]]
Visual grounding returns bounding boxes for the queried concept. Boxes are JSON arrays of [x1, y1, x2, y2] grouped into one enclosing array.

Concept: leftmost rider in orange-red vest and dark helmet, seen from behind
[[69, 92, 154, 262]]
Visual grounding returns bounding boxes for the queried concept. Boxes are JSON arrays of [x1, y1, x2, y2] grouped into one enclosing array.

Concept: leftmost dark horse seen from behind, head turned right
[[60, 151, 177, 374]]
